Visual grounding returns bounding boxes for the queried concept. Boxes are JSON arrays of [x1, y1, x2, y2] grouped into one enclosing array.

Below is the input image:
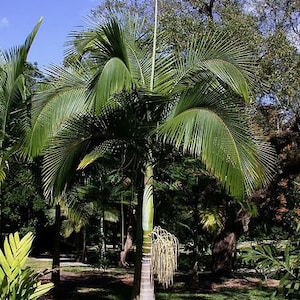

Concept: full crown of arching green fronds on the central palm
[[24, 14, 272, 200]]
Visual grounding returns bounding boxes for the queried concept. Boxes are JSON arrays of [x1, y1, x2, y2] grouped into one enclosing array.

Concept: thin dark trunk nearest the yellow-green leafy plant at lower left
[[51, 204, 62, 287]]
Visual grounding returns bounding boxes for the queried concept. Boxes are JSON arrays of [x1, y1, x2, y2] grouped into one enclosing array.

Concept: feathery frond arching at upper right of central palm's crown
[[176, 30, 257, 102]]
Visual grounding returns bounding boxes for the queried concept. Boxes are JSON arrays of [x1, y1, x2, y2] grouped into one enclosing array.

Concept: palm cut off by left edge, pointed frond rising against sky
[[0, 18, 42, 237]]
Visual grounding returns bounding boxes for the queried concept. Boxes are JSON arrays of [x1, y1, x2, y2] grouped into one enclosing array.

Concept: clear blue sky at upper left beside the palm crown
[[0, 0, 100, 68]]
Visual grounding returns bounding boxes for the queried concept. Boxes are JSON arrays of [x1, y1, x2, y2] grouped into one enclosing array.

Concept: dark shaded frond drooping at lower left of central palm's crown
[[43, 114, 126, 196]]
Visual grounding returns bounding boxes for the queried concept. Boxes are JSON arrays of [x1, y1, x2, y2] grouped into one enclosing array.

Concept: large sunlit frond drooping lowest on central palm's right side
[[157, 85, 274, 196]]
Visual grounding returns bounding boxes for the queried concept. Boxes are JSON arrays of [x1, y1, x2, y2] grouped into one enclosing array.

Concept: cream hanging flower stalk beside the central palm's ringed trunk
[[151, 226, 179, 288]]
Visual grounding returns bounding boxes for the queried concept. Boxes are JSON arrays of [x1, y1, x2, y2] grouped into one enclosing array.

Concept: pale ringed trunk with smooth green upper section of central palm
[[139, 163, 155, 300]]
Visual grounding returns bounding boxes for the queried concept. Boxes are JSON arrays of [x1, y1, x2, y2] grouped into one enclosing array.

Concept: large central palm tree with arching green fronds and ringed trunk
[[26, 11, 273, 299]]
